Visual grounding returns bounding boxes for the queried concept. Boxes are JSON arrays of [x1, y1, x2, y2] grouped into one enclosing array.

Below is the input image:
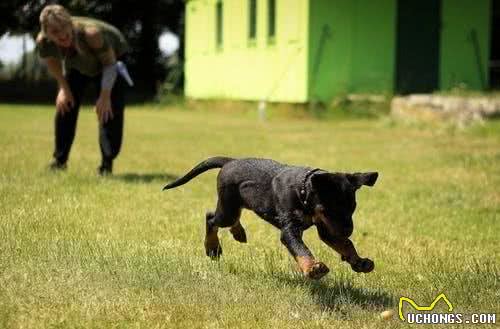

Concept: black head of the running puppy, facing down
[[311, 172, 378, 237]]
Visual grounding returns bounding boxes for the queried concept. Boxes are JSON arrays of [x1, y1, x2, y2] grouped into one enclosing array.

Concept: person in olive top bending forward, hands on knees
[[36, 5, 132, 175]]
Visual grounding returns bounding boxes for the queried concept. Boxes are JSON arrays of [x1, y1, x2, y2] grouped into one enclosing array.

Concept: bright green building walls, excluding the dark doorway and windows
[[185, 0, 491, 103]]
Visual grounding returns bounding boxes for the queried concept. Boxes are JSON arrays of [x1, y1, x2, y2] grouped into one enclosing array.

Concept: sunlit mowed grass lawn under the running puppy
[[0, 105, 500, 328]]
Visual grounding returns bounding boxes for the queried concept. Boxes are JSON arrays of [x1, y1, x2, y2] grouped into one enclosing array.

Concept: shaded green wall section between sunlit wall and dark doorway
[[308, 0, 396, 101]]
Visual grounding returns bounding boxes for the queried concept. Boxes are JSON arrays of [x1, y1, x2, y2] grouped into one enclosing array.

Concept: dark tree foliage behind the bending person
[[0, 0, 185, 94]]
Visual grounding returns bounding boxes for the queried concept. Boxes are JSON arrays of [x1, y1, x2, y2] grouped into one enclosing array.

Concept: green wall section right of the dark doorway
[[440, 0, 491, 90]]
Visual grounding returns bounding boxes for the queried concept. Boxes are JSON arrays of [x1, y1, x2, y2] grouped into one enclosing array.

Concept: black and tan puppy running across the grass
[[164, 157, 378, 279]]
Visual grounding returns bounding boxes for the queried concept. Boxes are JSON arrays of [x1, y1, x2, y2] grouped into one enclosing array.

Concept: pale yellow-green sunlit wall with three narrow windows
[[185, 0, 309, 103]]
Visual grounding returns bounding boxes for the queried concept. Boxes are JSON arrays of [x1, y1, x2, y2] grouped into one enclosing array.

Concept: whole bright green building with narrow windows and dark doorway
[[185, 0, 500, 103]]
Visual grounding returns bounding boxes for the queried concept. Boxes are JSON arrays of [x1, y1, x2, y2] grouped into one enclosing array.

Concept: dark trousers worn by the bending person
[[54, 70, 125, 164]]
